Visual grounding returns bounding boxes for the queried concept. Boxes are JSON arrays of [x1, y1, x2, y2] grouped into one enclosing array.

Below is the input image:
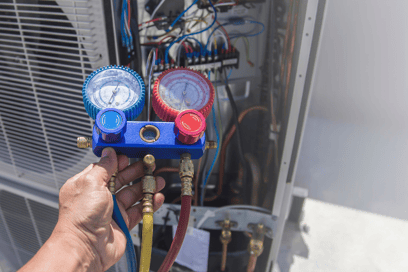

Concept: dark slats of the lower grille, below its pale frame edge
[[0, 190, 127, 272]]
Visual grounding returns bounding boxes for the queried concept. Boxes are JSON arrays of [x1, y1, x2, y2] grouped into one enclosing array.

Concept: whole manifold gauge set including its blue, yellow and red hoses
[[78, 66, 215, 272]]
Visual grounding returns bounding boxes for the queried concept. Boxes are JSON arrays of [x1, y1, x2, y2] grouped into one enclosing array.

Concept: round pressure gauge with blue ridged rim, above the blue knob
[[82, 66, 145, 120]]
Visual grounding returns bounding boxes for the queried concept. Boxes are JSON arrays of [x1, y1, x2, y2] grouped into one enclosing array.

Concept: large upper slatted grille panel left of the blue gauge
[[0, 0, 109, 191]]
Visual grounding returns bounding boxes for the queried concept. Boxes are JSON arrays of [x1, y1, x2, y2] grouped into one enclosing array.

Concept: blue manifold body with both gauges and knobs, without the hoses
[[82, 66, 215, 159]]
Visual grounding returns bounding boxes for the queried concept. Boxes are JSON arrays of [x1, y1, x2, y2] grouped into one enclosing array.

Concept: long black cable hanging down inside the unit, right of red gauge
[[221, 69, 249, 203]]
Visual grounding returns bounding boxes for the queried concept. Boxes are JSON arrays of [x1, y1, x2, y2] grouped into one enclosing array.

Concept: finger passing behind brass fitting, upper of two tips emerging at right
[[116, 177, 166, 209]]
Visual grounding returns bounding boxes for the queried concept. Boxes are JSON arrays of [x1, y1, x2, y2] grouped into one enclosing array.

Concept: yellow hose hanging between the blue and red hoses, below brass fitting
[[139, 213, 153, 272]]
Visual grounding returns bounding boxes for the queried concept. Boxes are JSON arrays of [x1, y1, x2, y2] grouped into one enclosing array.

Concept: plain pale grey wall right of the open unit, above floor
[[296, 0, 408, 219]]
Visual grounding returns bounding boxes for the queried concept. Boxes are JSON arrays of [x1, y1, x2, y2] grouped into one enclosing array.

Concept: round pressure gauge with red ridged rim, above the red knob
[[152, 68, 214, 122]]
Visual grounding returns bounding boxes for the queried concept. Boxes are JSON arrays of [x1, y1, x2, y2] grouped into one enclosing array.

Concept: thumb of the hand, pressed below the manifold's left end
[[87, 147, 118, 183]]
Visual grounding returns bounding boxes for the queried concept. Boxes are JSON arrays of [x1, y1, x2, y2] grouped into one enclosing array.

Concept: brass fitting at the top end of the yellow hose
[[142, 154, 156, 213]]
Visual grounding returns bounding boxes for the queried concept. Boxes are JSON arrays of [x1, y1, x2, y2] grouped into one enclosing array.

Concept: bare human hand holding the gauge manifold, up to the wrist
[[53, 148, 165, 271]]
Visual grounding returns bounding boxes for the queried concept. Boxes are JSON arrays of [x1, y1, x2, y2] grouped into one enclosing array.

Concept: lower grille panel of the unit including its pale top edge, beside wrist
[[0, 179, 127, 272]]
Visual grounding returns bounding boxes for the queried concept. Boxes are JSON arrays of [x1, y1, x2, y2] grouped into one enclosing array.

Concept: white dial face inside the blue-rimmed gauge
[[86, 69, 141, 110]]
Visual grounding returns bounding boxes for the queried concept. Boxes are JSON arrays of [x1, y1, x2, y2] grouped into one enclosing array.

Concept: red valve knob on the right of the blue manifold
[[174, 110, 207, 144]]
